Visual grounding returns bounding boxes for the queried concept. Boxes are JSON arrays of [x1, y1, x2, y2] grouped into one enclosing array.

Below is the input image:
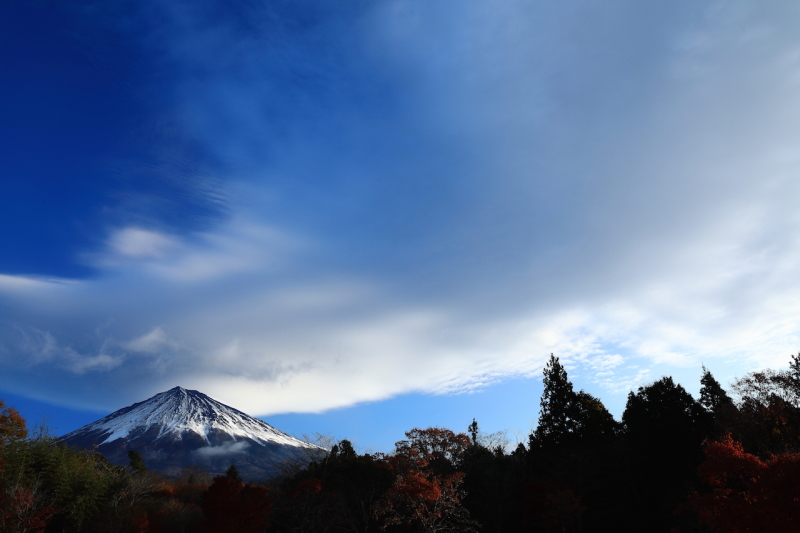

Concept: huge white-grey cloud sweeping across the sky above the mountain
[[0, 1, 800, 414]]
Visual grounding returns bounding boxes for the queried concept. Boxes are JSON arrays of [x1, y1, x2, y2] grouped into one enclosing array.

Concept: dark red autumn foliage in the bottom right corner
[[690, 435, 800, 533]]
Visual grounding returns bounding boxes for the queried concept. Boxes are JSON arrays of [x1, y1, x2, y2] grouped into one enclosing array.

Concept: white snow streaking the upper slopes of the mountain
[[62, 387, 317, 448]]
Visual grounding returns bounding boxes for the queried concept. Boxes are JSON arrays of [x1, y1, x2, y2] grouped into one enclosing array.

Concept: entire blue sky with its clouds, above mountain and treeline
[[0, 0, 800, 451]]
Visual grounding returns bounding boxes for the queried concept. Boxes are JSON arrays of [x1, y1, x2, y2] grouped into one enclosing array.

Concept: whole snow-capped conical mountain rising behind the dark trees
[[61, 387, 325, 479]]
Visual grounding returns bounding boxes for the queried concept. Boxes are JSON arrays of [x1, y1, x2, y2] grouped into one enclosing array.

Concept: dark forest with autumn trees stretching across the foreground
[[0, 355, 800, 533]]
